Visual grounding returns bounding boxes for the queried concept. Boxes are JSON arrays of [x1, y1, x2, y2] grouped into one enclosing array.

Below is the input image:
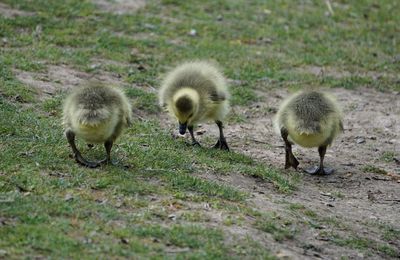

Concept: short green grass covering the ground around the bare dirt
[[0, 0, 400, 259]]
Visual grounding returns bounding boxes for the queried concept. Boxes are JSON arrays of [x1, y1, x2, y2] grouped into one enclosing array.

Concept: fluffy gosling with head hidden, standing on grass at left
[[63, 84, 132, 168]]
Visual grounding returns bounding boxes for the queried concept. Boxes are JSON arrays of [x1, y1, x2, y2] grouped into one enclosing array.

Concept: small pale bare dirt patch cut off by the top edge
[[93, 0, 146, 14]]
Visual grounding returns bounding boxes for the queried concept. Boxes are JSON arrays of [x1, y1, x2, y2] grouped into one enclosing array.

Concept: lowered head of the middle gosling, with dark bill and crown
[[173, 88, 199, 135]]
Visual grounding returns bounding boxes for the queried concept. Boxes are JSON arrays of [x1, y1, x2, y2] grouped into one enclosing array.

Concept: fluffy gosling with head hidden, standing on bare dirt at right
[[274, 91, 343, 175]]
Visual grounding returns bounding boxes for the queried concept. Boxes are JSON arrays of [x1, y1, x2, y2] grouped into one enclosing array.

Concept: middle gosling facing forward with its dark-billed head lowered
[[159, 61, 230, 150]]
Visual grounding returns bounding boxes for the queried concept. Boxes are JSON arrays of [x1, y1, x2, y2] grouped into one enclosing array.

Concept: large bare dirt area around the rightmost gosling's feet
[[161, 88, 400, 259]]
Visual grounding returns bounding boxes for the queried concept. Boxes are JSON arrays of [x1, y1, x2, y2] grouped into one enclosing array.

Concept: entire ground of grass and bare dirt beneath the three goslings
[[0, 0, 400, 259]]
